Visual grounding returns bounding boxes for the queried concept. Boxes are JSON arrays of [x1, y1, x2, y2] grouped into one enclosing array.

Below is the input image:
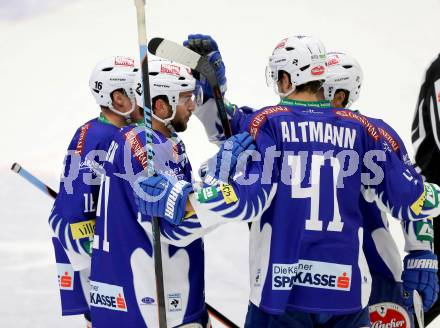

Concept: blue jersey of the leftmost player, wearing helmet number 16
[[49, 116, 118, 315]]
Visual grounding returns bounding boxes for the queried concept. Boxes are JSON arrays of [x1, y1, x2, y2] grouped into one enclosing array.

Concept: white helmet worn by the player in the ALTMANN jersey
[[266, 36, 327, 97]]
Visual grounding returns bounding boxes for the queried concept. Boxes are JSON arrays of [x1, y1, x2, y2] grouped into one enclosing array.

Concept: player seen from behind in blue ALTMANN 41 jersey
[[138, 36, 440, 327]]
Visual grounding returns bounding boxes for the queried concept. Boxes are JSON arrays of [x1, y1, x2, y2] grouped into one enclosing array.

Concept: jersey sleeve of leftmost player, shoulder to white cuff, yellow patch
[[49, 118, 118, 270]]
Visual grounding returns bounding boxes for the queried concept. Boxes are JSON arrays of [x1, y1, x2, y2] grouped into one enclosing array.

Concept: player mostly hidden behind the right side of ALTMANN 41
[[324, 52, 438, 327]]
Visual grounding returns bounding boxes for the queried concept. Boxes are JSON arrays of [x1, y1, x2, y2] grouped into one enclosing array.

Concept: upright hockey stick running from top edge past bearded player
[[134, 0, 167, 328]]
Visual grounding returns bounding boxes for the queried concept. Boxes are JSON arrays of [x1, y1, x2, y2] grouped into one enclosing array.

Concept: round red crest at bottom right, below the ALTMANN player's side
[[369, 302, 411, 328]]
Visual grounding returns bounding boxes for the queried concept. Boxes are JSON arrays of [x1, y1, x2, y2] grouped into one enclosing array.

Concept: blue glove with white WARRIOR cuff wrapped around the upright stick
[[135, 173, 193, 225]]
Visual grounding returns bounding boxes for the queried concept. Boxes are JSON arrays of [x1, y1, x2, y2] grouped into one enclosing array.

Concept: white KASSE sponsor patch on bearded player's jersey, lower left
[[90, 281, 127, 312]]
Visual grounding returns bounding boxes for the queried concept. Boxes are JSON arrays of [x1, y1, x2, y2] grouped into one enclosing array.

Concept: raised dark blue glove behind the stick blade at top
[[183, 34, 226, 102]]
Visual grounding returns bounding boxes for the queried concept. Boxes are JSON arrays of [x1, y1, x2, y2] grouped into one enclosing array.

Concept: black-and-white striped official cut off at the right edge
[[412, 55, 440, 324]]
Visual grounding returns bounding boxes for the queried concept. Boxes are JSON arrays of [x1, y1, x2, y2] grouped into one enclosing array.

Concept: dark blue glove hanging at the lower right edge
[[402, 251, 439, 312]]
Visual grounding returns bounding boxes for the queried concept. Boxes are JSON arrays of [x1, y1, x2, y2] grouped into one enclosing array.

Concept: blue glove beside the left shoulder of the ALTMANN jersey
[[199, 132, 255, 184]]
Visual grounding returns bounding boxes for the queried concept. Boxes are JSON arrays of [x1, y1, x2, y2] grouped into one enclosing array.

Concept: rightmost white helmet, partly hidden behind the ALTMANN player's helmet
[[324, 52, 363, 107]]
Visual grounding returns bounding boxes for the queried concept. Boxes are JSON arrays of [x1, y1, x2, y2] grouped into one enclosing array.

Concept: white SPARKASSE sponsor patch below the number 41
[[272, 260, 351, 291]]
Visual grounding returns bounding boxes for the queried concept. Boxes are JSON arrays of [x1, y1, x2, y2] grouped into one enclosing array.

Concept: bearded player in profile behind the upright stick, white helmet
[[90, 60, 217, 328]]
